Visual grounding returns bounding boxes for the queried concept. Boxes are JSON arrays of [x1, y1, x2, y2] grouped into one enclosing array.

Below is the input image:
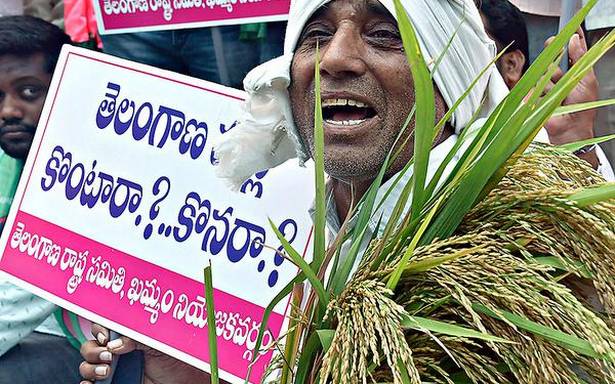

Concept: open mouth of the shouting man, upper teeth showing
[[322, 99, 376, 126]]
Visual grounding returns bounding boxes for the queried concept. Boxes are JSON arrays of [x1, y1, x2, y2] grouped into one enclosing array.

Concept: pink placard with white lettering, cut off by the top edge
[[91, 0, 290, 35]]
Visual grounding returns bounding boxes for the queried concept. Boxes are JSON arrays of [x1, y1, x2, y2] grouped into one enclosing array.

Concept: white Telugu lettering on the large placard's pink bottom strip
[[9, 221, 275, 361]]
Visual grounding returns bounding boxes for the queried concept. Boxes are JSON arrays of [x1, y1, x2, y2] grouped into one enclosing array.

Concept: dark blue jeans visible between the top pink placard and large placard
[[101, 23, 285, 88]]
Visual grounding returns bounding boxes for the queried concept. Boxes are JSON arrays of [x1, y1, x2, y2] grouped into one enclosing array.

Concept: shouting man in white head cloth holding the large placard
[[81, 0, 612, 384]]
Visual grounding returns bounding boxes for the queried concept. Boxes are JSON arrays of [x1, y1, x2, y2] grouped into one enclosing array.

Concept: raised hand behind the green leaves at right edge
[[545, 29, 599, 168]]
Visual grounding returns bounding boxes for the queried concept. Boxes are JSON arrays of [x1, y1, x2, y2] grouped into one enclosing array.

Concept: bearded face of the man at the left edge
[[0, 54, 51, 159]]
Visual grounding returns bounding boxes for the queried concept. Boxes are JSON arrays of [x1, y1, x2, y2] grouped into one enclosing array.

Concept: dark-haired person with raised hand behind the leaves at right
[[480, 0, 614, 179]]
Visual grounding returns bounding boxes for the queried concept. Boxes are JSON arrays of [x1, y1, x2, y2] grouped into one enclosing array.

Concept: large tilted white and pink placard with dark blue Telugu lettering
[[0, 47, 314, 383]]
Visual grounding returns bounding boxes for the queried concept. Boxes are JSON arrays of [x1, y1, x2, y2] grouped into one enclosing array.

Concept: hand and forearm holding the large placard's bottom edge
[[79, 324, 210, 384]]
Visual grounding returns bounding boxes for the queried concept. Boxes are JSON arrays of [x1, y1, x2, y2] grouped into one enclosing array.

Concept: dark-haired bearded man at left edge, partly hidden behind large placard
[[0, 16, 79, 384]]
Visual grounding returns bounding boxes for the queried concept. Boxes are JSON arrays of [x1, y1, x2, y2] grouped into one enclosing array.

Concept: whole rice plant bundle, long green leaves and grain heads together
[[205, 0, 615, 384]]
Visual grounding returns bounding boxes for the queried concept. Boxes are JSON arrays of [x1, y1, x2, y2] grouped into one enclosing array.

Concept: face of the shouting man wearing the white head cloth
[[289, 0, 444, 180]]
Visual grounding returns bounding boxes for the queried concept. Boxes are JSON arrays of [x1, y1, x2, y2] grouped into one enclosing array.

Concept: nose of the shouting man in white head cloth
[[320, 26, 367, 78]]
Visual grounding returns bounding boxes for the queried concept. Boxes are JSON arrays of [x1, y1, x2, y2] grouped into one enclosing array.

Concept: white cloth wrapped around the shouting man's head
[[215, 0, 508, 188]]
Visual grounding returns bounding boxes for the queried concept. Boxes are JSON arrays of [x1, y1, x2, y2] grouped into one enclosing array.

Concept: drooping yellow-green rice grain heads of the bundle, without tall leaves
[[320, 147, 615, 384]]
